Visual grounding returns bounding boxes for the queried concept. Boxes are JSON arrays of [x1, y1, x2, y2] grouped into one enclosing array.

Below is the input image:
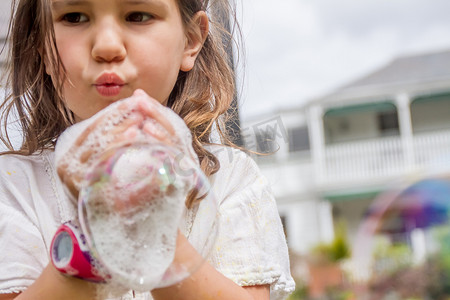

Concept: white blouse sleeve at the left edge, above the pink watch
[[0, 156, 48, 294]]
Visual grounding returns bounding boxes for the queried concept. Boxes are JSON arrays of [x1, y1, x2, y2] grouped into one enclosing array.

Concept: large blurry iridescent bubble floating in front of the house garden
[[343, 179, 450, 300]]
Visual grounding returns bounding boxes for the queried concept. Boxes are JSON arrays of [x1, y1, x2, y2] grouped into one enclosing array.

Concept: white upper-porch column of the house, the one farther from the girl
[[396, 93, 415, 170]]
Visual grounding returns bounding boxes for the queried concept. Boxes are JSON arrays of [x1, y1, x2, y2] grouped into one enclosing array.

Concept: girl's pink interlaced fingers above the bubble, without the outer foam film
[[58, 90, 184, 198]]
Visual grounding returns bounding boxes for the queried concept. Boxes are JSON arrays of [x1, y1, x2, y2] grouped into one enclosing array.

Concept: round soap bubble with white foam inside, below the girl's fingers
[[79, 143, 217, 292]]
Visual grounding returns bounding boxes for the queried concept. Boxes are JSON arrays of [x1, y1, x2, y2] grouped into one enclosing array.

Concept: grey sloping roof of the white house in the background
[[314, 50, 450, 106]]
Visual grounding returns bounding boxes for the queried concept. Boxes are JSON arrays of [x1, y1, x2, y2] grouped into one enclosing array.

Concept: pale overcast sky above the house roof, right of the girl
[[239, 0, 450, 119]]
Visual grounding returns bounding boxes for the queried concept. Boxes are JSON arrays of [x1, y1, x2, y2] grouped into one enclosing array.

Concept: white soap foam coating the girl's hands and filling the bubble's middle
[[55, 92, 198, 291]]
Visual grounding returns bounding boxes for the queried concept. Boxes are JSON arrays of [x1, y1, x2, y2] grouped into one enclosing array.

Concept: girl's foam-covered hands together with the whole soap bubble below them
[[55, 93, 218, 292]]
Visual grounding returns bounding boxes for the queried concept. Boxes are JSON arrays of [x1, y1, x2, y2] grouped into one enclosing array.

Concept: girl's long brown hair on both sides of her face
[[0, 0, 239, 202]]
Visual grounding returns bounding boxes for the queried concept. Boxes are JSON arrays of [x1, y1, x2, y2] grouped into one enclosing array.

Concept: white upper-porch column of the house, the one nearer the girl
[[308, 105, 326, 183]]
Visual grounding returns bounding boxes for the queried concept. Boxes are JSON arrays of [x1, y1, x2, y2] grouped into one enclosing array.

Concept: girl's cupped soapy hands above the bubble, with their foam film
[[55, 90, 198, 199]]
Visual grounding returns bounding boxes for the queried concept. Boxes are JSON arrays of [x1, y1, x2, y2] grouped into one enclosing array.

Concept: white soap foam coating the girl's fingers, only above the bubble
[[55, 95, 198, 196]]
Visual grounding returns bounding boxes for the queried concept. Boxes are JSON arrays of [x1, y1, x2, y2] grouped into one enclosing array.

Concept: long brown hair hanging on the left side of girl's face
[[0, 0, 73, 155]]
